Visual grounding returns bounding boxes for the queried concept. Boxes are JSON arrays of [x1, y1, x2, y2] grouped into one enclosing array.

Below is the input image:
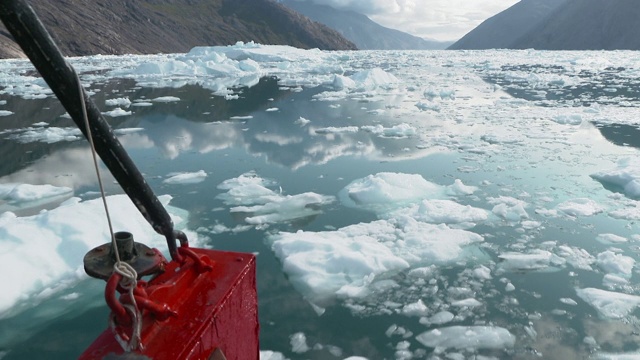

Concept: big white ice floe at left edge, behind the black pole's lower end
[[0, 194, 198, 318]]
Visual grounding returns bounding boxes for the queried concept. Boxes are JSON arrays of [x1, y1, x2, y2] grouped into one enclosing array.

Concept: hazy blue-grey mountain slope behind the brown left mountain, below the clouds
[[280, 0, 451, 50]]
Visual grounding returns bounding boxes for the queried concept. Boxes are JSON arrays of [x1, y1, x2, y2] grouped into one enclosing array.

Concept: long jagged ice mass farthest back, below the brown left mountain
[[108, 42, 336, 98]]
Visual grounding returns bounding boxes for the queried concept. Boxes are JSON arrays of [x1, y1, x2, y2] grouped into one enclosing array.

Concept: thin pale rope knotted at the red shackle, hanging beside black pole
[[76, 76, 142, 352]]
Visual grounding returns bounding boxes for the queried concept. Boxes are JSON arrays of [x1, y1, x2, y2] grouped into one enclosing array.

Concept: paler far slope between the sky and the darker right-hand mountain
[[449, 0, 568, 50]]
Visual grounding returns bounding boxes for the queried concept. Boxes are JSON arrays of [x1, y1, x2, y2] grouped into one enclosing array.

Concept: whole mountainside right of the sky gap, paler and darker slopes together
[[449, 0, 640, 50]]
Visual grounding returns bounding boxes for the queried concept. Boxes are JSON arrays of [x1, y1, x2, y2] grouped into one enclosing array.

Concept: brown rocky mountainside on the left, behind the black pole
[[0, 0, 356, 58]]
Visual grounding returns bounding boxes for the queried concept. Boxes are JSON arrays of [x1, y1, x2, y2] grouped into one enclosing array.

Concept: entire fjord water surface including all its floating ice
[[0, 43, 640, 360]]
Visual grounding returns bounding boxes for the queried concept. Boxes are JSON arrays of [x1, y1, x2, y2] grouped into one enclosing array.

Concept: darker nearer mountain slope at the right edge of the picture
[[512, 0, 640, 50]]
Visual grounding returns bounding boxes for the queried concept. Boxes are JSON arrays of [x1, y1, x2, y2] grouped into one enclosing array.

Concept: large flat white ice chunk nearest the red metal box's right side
[[270, 217, 483, 303]]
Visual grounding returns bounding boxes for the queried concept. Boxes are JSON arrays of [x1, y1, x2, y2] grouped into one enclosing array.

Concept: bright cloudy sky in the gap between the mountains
[[313, 0, 519, 41]]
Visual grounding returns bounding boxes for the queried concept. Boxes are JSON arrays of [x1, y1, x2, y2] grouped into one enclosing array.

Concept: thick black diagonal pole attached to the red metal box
[[0, 0, 180, 260]]
